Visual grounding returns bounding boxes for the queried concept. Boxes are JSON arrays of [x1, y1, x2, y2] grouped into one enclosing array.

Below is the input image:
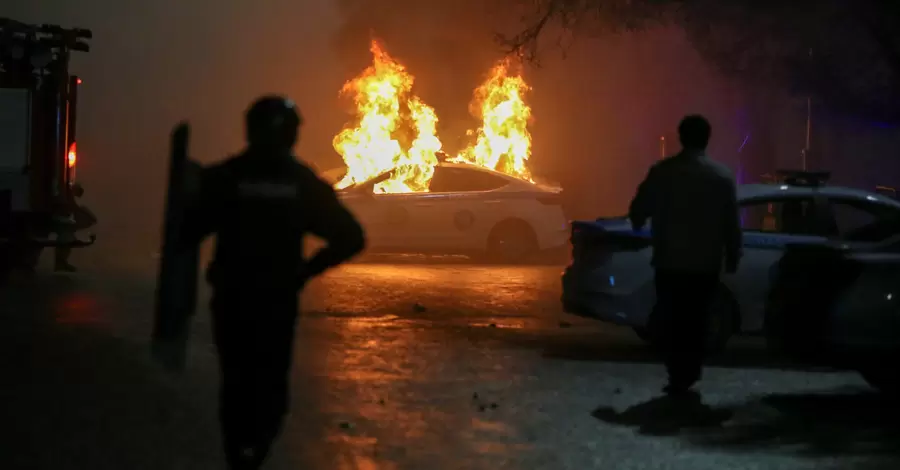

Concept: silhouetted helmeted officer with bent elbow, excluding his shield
[[185, 97, 365, 470]]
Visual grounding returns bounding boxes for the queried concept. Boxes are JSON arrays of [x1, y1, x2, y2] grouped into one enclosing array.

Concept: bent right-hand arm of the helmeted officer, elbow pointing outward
[[304, 176, 366, 278]]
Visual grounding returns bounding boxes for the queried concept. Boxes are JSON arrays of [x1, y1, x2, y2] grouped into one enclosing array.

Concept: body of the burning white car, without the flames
[[339, 162, 569, 262]]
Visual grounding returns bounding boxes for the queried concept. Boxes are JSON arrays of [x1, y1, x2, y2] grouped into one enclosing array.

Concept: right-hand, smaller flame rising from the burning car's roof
[[454, 60, 532, 181]]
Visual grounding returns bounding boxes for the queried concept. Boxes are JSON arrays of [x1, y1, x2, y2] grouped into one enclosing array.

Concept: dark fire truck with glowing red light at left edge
[[0, 18, 94, 282]]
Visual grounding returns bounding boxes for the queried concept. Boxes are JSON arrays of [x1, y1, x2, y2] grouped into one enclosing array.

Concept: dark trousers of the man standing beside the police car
[[656, 269, 719, 387]]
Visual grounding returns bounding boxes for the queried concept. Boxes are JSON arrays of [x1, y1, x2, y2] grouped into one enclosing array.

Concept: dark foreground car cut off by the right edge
[[765, 218, 900, 394]]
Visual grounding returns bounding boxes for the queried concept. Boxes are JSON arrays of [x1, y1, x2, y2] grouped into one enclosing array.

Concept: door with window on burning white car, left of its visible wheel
[[428, 166, 509, 251]]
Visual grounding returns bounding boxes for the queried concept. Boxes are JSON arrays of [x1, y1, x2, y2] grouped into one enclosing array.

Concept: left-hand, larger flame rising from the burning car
[[333, 41, 442, 193]]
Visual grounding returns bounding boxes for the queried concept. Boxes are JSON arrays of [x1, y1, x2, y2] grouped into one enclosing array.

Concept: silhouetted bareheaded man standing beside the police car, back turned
[[628, 116, 741, 394]]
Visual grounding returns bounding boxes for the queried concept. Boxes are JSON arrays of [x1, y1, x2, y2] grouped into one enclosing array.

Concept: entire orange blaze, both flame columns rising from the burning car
[[333, 41, 532, 193]]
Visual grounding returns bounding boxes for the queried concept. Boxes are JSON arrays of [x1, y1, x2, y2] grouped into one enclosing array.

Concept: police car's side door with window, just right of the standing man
[[724, 195, 829, 332]]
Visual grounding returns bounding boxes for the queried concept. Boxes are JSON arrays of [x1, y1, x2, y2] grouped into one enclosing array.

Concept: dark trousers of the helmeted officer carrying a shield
[[211, 288, 298, 470]]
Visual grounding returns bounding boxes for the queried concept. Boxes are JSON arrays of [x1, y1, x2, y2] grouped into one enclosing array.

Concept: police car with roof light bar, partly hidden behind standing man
[[562, 172, 900, 348]]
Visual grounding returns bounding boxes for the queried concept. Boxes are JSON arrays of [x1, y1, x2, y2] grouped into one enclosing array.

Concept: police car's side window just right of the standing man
[[741, 198, 827, 235]]
